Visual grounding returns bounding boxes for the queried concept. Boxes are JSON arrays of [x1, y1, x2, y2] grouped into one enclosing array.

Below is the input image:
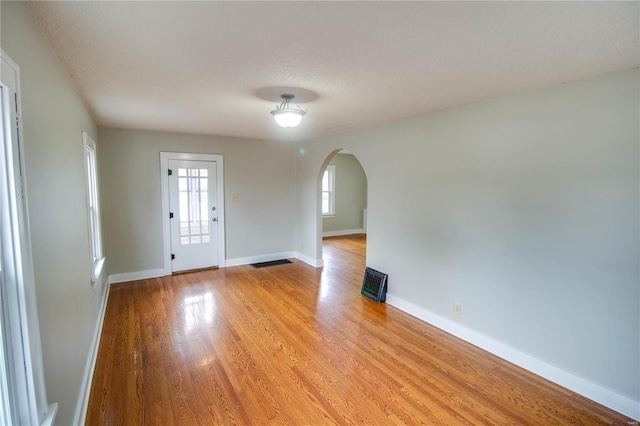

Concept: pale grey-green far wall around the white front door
[[99, 128, 295, 275]]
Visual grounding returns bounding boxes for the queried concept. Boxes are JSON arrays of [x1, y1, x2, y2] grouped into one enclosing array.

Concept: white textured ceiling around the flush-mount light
[[30, 1, 640, 140]]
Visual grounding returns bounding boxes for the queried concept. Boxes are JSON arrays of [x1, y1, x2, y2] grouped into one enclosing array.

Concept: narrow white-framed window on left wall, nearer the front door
[[82, 132, 104, 283]]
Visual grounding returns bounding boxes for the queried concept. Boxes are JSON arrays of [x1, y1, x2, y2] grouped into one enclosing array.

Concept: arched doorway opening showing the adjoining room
[[318, 149, 368, 264]]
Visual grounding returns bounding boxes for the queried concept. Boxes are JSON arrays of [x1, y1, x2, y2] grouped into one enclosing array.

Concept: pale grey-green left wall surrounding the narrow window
[[0, 1, 103, 425]]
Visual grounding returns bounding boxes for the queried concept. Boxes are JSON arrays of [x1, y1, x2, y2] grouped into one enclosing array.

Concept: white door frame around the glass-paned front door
[[160, 152, 226, 275]]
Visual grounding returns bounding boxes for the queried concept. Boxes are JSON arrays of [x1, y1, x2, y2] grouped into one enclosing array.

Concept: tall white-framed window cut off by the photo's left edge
[[0, 51, 58, 426]]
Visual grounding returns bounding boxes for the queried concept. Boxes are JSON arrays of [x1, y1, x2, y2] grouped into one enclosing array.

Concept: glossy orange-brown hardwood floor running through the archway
[[87, 236, 631, 426]]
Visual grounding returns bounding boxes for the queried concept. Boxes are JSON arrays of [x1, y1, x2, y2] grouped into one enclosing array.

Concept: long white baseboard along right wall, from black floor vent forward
[[387, 294, 640, 420]]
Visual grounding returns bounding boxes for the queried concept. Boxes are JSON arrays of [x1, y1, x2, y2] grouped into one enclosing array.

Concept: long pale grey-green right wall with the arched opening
[[296, 69, 640, 415]]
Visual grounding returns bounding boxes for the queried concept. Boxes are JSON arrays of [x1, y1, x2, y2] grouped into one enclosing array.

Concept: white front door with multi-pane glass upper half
[[169, 160, 218, 272]]
